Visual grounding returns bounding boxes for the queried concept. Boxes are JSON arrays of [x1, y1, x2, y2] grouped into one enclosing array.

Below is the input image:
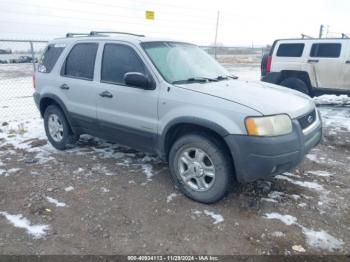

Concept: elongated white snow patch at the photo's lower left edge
[[0, 212, 49, 239]]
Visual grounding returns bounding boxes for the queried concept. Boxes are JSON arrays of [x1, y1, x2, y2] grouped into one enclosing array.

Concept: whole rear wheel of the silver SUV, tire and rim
[[44, 105, 77, 150]]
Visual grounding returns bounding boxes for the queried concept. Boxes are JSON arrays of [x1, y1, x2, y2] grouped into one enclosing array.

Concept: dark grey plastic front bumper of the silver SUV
[[225, 120, 322, 183]]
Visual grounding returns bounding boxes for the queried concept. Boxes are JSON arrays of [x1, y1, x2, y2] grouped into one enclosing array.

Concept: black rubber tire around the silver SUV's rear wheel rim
[[44, 105, 79, 150]]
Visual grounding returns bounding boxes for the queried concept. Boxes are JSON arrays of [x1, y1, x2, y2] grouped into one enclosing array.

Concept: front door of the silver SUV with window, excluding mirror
[[97, 42, 159, 151]]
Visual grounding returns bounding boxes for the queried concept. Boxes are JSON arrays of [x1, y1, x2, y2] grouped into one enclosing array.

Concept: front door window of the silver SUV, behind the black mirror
[[101, 44, 146, 85]]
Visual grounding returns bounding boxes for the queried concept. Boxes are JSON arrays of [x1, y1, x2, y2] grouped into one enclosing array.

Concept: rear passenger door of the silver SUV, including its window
[[58, 42, 98, 131]]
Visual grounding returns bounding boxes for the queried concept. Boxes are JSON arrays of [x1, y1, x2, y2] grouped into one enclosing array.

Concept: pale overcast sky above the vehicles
[[0, 0, 350, 46]]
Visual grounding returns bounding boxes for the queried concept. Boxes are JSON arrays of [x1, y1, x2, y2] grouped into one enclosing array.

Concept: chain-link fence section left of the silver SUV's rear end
[[0, 39, 46, 123]]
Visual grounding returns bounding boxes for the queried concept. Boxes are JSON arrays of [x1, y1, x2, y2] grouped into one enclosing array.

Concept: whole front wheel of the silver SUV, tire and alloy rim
[[169, 134, 233, 204]]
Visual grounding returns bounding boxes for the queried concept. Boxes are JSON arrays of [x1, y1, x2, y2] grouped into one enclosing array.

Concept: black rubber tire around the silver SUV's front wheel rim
[[169, 133, 234, 204]]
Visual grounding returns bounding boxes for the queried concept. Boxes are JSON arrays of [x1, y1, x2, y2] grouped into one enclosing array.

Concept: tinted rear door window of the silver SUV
[[62, 43, 98, 80]]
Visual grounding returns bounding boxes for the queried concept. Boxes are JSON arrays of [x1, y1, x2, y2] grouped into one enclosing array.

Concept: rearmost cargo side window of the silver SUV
[[38, 44, 66, 73]]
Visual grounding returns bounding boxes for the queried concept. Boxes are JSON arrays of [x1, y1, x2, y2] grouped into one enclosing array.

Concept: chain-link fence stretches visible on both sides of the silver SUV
[[0, 39, 267, 124]]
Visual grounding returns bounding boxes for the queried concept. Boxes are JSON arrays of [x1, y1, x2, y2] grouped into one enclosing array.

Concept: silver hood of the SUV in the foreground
[[177, 80, 315, 119]]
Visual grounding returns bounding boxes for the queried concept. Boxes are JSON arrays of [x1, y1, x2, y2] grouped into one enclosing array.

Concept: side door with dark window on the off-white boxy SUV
[[307, 41, 345, 89]]
